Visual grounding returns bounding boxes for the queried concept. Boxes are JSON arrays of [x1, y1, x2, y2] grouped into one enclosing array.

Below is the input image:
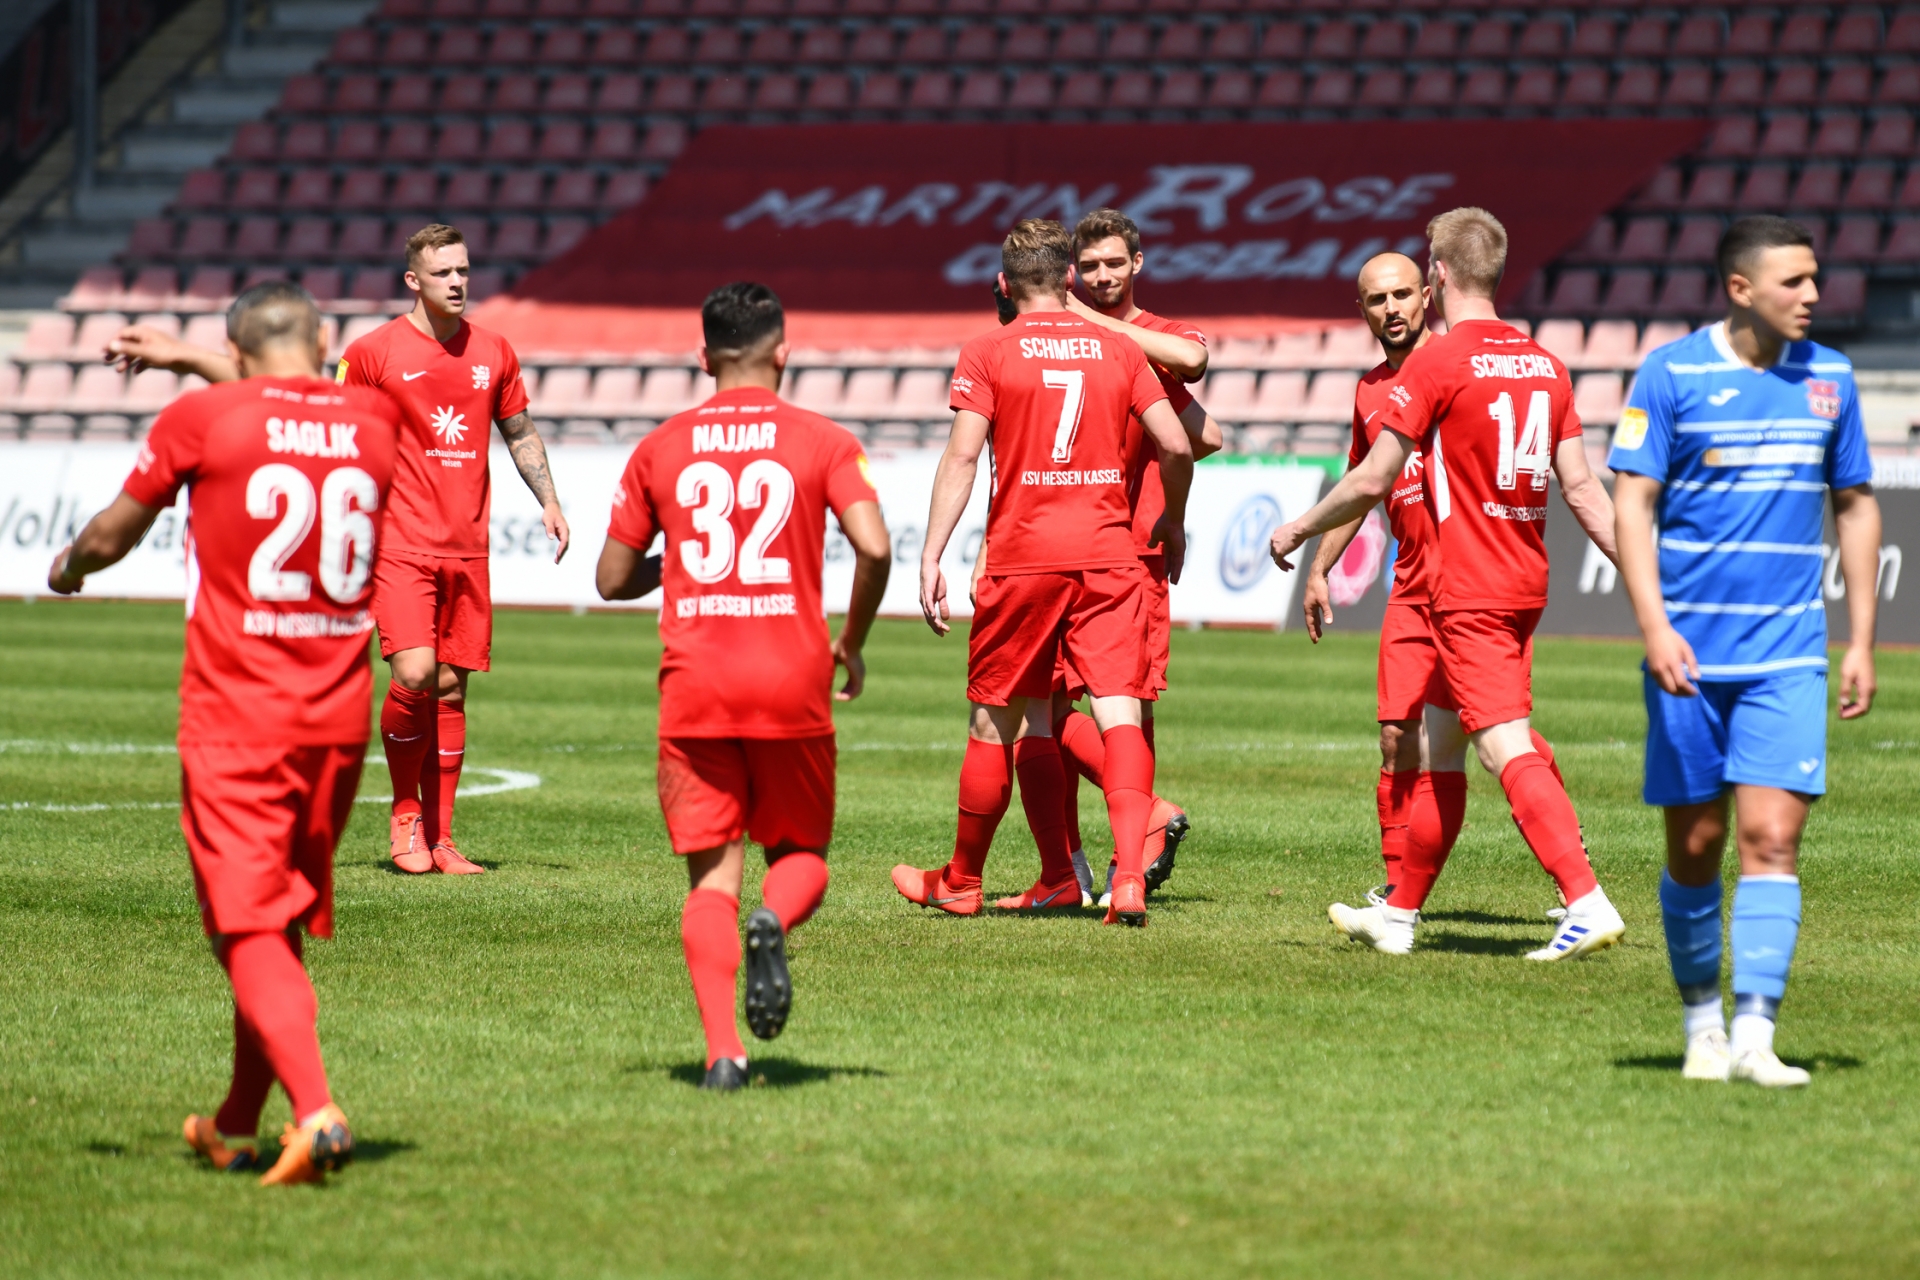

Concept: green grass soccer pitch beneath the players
[[0, 603, 1920, 1280]]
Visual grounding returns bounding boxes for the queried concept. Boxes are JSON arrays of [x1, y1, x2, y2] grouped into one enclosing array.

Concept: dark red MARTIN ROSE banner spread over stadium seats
[[515, 121, 1705, 317]]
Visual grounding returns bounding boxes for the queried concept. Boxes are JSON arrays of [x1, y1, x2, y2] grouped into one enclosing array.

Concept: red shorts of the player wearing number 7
[[966, 564, 1154, 706]]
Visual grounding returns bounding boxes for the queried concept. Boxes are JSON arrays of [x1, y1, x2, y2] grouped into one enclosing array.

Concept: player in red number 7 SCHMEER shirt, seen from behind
[[893, 219, 1192, 925]]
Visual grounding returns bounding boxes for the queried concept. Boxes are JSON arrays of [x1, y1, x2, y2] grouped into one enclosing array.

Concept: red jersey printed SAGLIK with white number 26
[[125, 378, 399, 747]]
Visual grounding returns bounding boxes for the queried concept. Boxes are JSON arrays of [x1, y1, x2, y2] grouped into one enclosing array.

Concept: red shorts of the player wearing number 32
[[659, 733, 837, 854]]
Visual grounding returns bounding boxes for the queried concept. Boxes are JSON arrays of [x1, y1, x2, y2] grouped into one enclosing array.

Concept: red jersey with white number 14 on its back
[[1382, 320, 1580, 608]]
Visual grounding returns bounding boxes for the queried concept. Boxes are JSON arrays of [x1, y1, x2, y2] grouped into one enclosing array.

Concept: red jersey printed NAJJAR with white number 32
[[607, 388, 879, 739]]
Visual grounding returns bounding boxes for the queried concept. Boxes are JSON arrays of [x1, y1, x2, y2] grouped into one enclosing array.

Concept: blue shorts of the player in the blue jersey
[[1642, 670, 1826, 806]]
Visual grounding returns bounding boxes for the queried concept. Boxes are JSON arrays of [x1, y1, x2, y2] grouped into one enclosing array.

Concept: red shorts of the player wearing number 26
[[180, 743, 367, 938]]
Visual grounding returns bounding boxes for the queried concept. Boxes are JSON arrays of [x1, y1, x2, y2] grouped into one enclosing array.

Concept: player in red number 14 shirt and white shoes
[[1273, 209, 1626, 961]]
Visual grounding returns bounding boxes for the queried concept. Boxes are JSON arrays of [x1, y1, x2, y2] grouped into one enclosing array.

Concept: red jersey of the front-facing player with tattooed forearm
[[336, 317, 526, 560]]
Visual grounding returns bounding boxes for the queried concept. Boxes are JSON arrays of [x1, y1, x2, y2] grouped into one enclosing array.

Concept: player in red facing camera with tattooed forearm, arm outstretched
[[106, 223, 572, 875]]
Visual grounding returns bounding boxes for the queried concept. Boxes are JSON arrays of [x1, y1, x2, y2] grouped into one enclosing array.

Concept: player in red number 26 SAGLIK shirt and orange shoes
[[46, 282, 399, 1184]]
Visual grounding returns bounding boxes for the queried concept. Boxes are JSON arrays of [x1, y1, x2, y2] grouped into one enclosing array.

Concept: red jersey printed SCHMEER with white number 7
[[948, 311, 1167, 576]]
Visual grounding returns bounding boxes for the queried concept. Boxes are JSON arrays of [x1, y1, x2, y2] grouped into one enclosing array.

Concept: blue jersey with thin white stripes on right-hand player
[[1607, 324, 1874, 679]]
